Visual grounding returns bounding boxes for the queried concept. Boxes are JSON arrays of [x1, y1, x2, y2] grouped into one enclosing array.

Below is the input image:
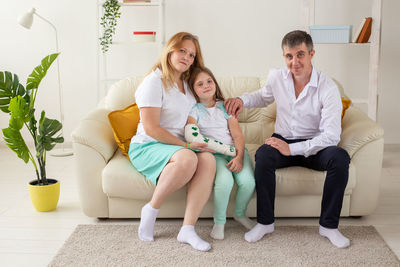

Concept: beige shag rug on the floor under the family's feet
[[49, 223, 400, 267]]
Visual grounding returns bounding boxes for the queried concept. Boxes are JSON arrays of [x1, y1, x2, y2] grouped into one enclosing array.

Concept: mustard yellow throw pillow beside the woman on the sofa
[[108, 103, 140, 158]]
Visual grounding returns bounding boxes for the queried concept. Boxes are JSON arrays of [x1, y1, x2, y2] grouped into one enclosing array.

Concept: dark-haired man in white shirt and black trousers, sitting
[[225, 31, 350, 248]]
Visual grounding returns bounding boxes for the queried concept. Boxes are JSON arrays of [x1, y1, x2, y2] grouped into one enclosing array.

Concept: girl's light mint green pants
[[214, 149, 255, 224]]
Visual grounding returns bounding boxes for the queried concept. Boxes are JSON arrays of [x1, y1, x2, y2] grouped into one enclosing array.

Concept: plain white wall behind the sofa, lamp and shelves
[[0, 0, 400, 143]]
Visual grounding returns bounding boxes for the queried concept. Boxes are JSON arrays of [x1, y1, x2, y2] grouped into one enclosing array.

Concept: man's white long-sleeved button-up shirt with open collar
[[240, 67, 342, 157]]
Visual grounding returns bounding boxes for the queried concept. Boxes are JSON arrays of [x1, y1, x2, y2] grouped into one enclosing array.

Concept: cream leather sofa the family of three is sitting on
[[72, 77, 383, 218]]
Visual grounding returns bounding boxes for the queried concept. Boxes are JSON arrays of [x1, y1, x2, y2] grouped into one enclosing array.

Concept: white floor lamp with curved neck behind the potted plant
[[18, 8, 73, 157]]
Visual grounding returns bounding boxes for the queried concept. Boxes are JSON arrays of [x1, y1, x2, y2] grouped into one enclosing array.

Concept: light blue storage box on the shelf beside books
[[310, 25, 351, 43]]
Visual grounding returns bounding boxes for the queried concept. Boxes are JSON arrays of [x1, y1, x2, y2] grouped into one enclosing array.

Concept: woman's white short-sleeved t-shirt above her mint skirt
[[131, 69, 196, 143]]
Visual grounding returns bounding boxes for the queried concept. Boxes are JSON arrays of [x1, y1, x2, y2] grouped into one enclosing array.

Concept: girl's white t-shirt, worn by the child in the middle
[[189, 101, 233, 145]]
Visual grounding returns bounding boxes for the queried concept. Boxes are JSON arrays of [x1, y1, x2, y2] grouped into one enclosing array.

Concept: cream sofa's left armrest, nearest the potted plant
[[72, 108, 117, 218]]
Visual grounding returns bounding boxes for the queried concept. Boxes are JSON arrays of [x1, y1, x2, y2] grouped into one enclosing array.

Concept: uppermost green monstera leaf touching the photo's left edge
[[0, 71, 29, 113]]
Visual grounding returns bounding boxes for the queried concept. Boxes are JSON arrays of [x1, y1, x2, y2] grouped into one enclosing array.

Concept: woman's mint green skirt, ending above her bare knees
[[128, 142, 184, 185]]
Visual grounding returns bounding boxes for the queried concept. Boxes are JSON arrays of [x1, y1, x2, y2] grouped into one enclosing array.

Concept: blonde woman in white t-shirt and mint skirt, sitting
[[129, 32, 216, 251]]
